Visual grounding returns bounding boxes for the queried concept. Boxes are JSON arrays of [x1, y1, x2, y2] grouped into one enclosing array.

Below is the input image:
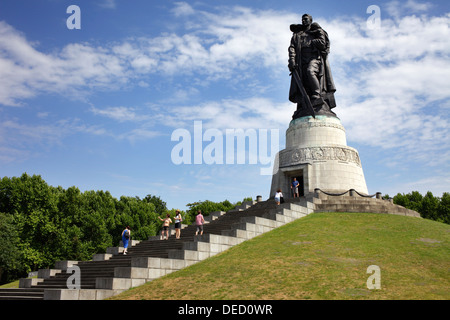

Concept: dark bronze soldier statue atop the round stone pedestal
[[289, 14, 336, 119]]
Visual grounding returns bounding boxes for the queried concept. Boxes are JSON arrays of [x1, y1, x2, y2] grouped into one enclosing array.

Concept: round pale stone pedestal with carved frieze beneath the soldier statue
[[270, 116, 368, 198]]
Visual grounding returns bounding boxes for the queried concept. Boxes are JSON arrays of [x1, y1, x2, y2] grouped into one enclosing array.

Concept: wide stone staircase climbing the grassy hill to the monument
[[0, 199, 314, 300]]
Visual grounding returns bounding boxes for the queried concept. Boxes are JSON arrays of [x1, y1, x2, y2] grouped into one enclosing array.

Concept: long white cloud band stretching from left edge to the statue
[[0, 6, 294, 105]]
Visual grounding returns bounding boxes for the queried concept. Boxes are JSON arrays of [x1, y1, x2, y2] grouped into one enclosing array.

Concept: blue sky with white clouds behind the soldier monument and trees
[[0, 0, 450, 210]]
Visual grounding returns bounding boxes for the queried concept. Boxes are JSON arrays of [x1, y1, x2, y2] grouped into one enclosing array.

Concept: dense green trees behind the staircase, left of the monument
[[0, 173, 250, 283]]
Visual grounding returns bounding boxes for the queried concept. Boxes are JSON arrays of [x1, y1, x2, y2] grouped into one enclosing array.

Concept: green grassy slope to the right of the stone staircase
[[112, 213, 450, 300]]
